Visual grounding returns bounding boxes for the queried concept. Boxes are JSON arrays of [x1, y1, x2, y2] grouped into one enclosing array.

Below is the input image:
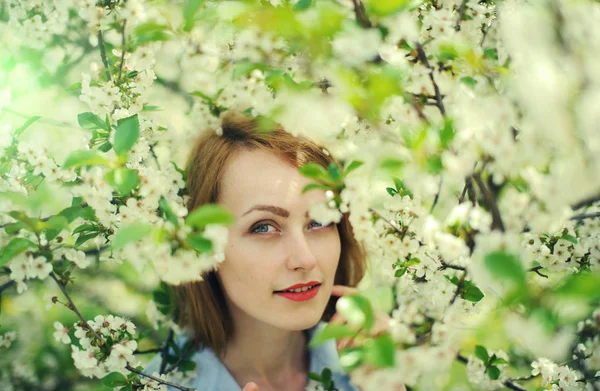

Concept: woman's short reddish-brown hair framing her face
[[173, 112, 365, 355]]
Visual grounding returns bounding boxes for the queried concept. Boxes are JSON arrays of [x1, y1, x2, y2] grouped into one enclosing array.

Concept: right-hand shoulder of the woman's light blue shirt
[[308, 322, 358, 391]]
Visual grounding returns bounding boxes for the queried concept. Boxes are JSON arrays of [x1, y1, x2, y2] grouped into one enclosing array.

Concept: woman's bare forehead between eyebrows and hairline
[[219, 150, 325, 216]]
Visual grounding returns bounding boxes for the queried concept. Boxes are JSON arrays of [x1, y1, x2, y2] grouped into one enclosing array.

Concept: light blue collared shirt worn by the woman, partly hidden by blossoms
[[144, 322, 358, 391]]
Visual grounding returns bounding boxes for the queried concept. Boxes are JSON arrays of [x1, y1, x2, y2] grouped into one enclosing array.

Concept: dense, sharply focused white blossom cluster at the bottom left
[[69, 315, 139, 378]]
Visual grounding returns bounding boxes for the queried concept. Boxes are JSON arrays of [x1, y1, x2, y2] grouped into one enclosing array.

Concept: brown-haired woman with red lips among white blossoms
[[149, 113, 365, 391]]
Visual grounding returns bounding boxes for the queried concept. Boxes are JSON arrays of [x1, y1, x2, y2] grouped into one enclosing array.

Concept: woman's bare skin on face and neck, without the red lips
[[217, 150, 341, 391]]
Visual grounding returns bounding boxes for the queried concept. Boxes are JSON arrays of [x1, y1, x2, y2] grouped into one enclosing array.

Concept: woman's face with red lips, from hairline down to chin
[[218, 150, 341, 330]]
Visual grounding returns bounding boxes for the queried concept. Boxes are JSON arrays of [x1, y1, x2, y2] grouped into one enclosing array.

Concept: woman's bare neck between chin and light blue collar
[[221, 320, 308, 386]]
